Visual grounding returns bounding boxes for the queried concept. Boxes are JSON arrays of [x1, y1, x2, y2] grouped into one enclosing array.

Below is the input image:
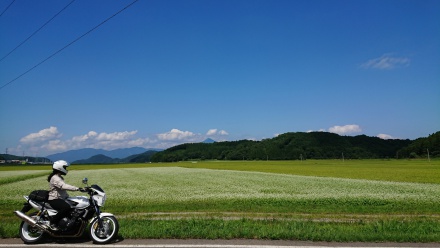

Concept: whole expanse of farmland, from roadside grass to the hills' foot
[[0, 160, 440, 242]]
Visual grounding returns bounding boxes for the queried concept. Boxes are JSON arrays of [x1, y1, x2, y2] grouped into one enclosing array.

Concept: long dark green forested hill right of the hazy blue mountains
[[152, 132, 413, 162]]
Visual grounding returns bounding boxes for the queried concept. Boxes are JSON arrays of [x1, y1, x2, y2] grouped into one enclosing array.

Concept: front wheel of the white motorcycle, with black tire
[[89, 216, 119, 244]]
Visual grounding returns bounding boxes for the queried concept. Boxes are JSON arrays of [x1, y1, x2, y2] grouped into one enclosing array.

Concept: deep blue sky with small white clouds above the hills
[[0, 0, 440, 156]]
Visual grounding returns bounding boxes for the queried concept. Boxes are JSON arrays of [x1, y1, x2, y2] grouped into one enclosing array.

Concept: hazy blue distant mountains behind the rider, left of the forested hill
[[47, 147, 161, 163]]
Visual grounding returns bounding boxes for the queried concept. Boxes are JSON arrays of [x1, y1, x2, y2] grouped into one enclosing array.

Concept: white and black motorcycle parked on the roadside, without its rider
[[14, 178, 119, 244]]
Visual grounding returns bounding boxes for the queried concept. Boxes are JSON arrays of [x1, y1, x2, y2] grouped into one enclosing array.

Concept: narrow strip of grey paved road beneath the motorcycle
[[0, 239, 440, 248]]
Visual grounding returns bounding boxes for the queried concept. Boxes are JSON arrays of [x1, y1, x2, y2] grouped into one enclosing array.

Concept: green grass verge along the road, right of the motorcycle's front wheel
[[120, 218, 440, 242]]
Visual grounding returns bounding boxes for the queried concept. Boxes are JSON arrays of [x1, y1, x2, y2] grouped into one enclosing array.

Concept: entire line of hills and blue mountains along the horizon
[[0, 131, 440, 164]]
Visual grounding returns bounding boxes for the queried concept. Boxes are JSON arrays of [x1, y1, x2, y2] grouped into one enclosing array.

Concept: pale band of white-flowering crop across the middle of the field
[[0, 167, 440, 212]]
